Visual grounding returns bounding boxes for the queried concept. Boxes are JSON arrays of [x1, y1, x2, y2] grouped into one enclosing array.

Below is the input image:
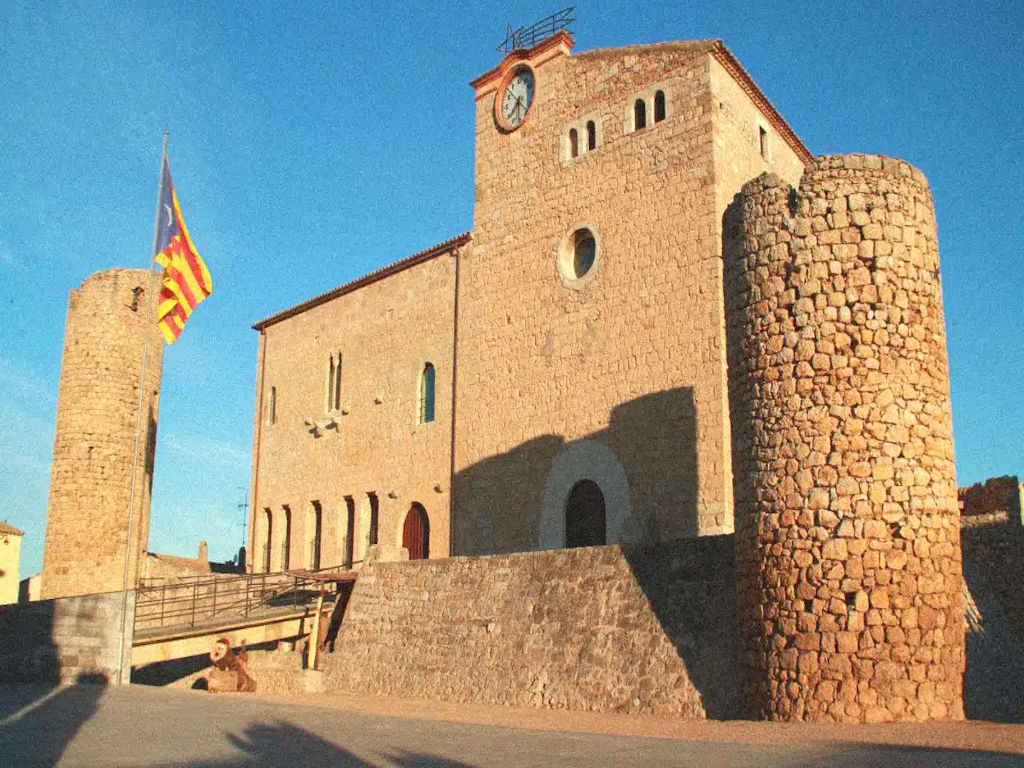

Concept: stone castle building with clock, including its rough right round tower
[[243, 33, 964, 720]]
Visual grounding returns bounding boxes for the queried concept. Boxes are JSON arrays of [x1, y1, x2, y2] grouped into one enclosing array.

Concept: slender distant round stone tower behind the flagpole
[[43, 269, 164, 598]]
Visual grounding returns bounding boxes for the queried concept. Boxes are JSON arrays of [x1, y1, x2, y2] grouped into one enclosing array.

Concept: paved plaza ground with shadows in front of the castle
[[0, 685, 1024, 768]]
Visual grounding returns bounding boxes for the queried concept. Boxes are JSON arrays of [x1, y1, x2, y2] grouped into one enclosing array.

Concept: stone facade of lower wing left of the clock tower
[[247, 239, 465, 572]]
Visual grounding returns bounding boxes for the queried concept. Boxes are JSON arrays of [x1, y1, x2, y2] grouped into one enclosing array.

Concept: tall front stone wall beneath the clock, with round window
[[452, 43, 806, 555]]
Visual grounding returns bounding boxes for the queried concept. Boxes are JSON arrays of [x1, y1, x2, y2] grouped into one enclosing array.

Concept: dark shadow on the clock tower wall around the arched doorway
[[451, 387, 698, 555]]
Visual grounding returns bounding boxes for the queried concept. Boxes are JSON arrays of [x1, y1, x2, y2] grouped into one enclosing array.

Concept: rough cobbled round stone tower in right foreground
[[723, 156, 965, 722]]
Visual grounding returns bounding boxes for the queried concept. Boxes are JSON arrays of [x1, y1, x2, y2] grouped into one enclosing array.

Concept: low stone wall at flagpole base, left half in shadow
[[0, 592, 135, 683]]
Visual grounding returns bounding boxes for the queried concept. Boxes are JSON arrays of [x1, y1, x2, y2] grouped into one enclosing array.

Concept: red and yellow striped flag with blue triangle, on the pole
[[156, 155, 213, 344]]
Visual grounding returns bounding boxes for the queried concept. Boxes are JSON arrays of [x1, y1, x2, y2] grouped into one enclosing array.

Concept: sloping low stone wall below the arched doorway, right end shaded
[[324, 536, 739, 718]]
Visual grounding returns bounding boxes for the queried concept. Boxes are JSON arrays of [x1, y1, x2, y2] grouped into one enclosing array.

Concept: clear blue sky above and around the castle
[[0, 0, 1024, 575]]
